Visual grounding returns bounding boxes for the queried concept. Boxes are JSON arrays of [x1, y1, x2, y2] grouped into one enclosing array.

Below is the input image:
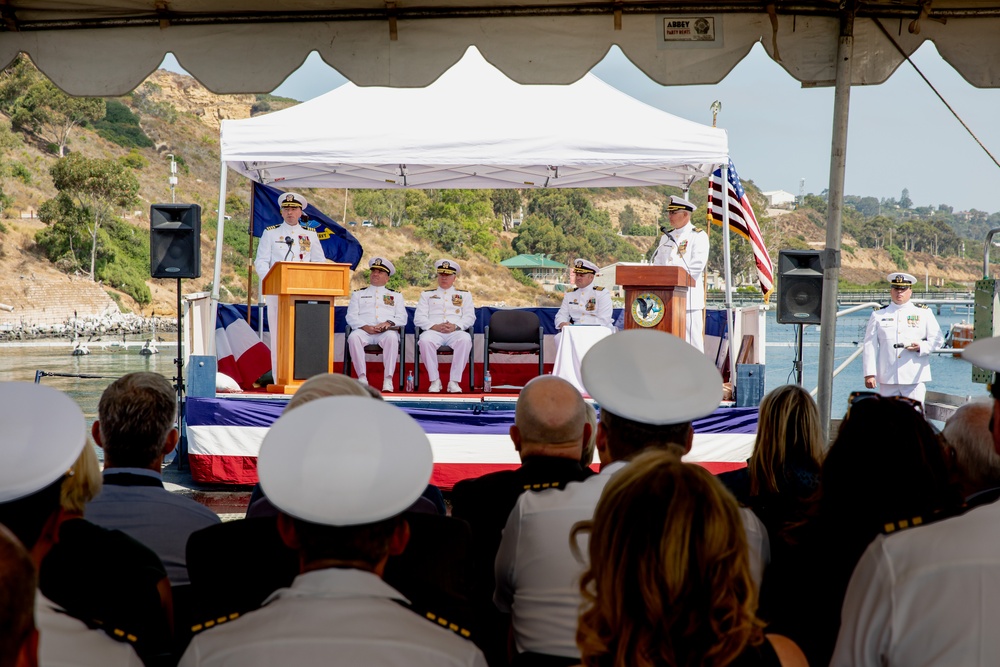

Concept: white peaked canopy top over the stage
[[221, 48, 729, 190]]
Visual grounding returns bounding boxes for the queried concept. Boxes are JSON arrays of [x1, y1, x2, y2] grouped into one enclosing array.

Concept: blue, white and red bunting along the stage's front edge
[[186, 392, 757, 491]]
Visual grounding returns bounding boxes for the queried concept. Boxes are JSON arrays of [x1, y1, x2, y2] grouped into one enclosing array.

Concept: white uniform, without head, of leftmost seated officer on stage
[[347, 285, 406, 380]]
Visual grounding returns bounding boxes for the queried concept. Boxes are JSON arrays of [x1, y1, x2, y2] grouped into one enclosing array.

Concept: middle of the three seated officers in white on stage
[[413, 259, 476, 394]]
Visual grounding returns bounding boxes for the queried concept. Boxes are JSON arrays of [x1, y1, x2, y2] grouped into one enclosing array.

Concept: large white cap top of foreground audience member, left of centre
[[257, 396, 434, 526]]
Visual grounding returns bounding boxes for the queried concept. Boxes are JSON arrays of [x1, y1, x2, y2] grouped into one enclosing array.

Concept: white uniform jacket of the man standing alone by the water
[[863, 301, 944, 384]]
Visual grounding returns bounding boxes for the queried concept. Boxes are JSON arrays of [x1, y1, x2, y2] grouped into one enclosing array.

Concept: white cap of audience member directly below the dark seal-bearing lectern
[[580, 329, 722, 425]]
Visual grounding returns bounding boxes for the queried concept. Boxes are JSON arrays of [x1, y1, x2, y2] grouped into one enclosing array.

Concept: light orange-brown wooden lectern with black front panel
[[263, 262, 351, 394]]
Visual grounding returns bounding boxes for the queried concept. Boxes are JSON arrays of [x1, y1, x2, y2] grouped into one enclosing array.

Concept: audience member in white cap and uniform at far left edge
[[0, 382, 142, 667]]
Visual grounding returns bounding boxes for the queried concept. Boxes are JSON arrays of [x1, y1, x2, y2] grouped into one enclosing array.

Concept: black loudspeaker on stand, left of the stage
[[149, 204, 201, 278]]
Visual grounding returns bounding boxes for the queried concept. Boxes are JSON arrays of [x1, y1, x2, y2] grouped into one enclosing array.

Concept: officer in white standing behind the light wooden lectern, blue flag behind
[[253, 192, 326, 382]]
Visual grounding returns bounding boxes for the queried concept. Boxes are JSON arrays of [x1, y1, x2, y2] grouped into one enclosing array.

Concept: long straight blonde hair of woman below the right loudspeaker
[[747, 384, 823, 496]]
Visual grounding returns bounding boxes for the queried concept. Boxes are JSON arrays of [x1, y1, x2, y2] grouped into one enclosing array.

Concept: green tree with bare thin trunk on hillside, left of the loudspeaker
[[49, 153, 139, 280]]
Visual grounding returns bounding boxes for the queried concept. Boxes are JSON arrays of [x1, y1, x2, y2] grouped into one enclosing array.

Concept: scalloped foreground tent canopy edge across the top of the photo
[[0, 0, 1000, 95]]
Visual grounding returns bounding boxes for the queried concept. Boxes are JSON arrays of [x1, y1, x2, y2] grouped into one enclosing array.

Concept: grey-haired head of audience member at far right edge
[[943, 399, 1000, 505]]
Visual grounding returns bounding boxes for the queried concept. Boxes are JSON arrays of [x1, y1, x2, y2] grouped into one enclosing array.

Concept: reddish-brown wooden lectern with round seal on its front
[[615, 264, 695, 339]]
